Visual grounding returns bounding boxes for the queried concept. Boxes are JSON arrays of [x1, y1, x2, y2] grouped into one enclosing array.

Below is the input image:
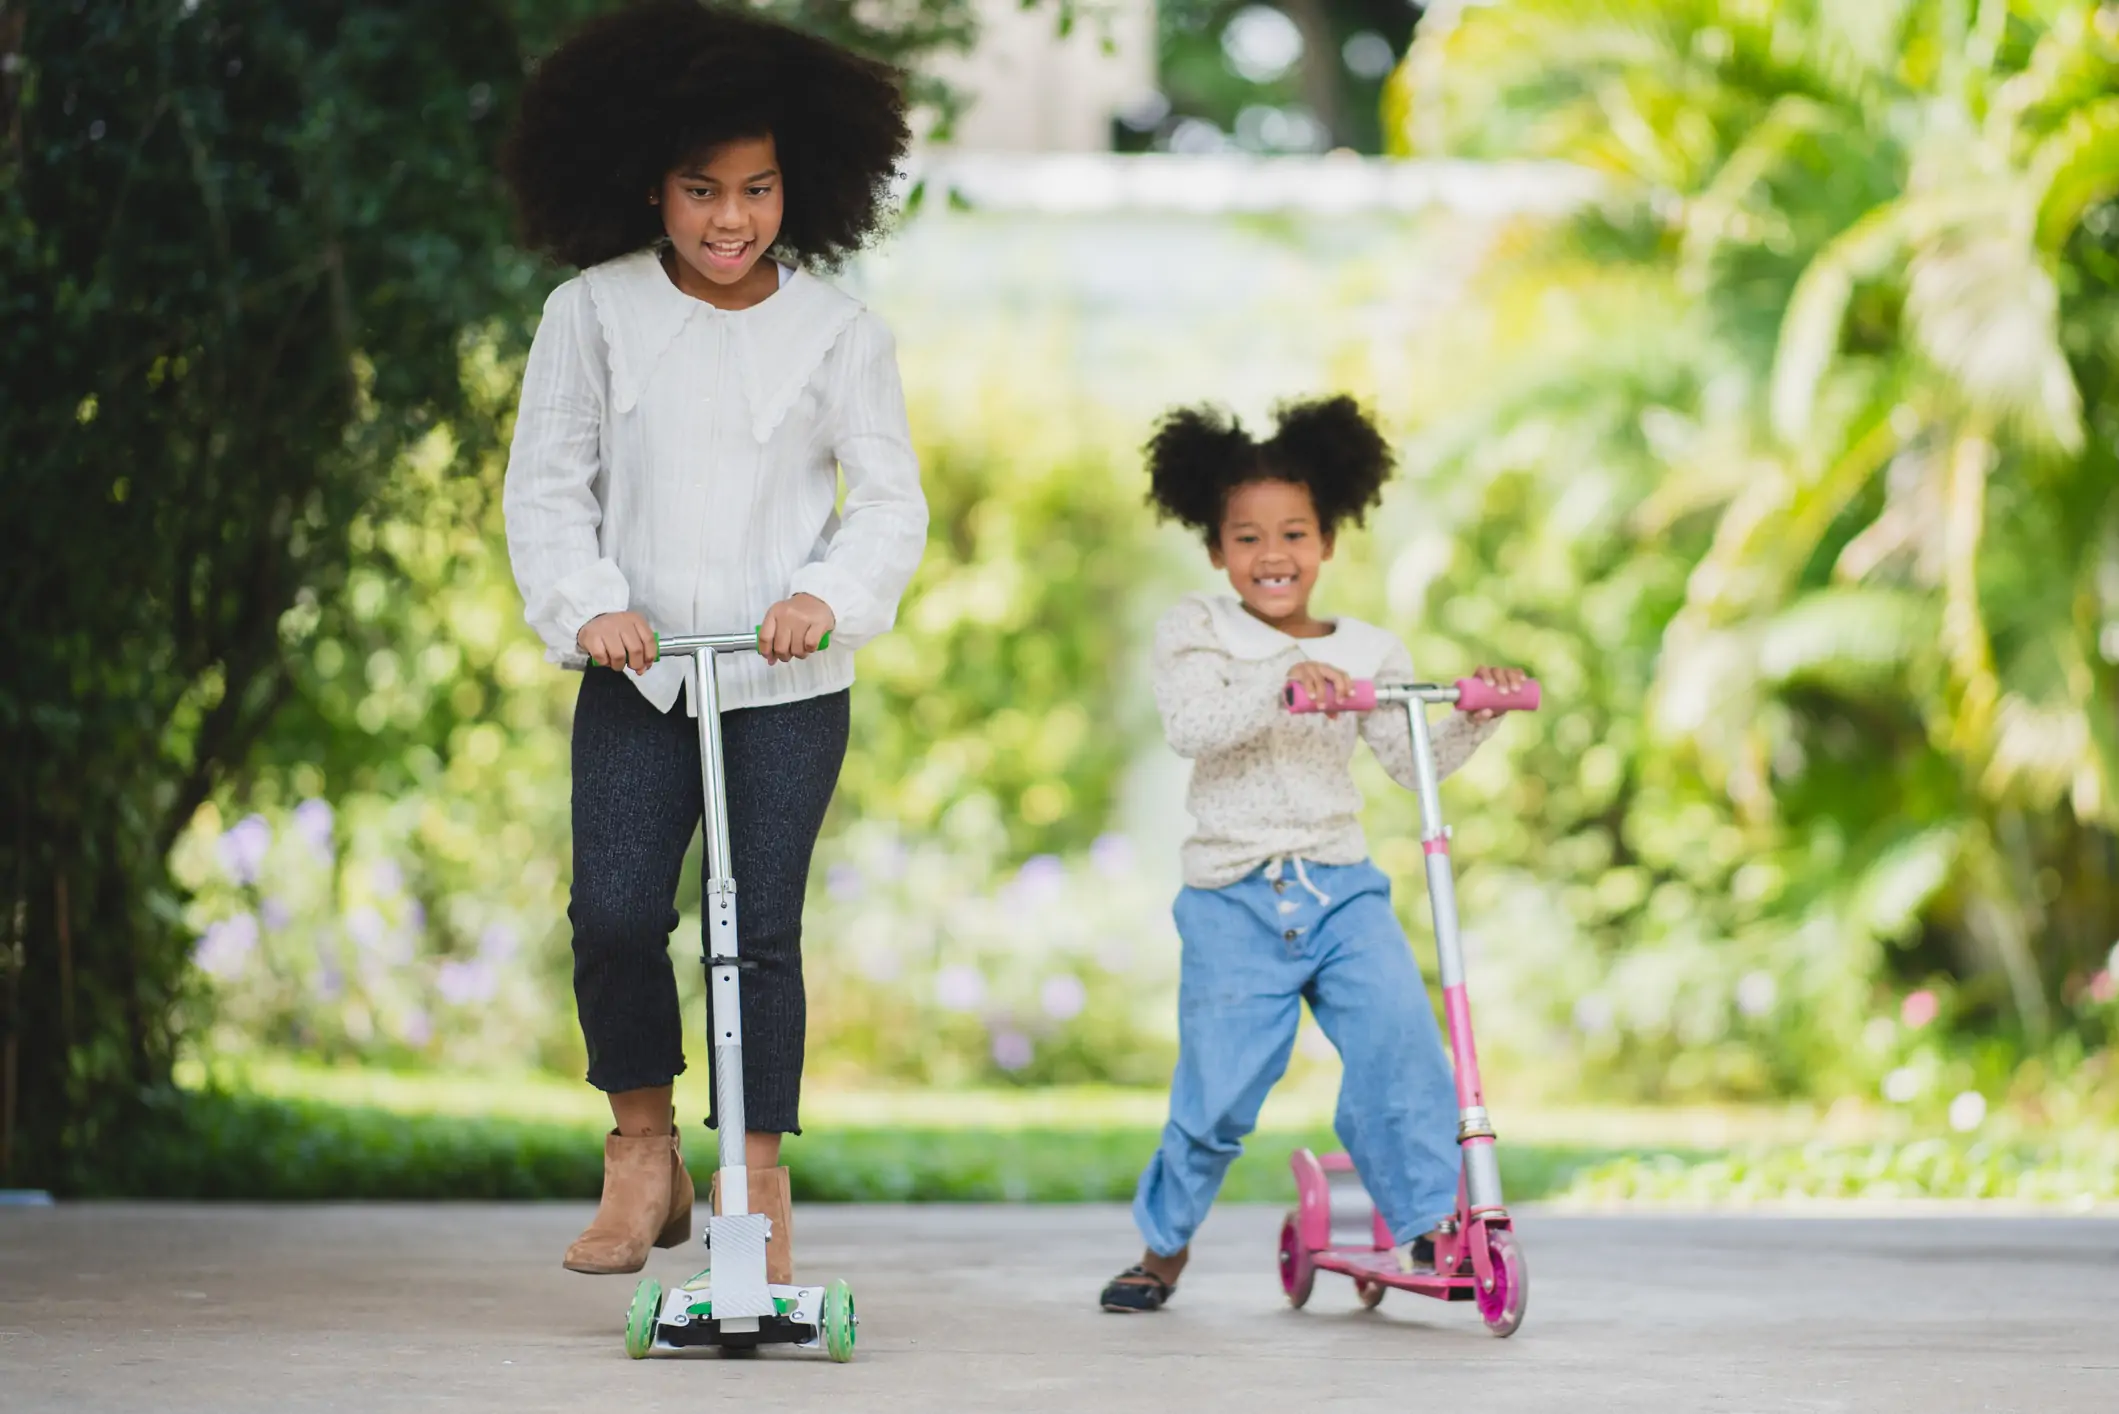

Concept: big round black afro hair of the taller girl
[[502, 0, 911, 267]]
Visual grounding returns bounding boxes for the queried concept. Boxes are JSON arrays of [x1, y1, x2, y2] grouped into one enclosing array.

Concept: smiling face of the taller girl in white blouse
[[651, 138, 786, 307]]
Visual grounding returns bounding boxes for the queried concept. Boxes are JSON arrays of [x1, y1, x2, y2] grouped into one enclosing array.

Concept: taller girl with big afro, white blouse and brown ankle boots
[[504, 0, 928, 1283]]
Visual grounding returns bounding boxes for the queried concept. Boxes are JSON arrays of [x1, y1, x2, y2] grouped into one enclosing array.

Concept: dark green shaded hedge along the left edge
[[0, 0, 521, 1177]]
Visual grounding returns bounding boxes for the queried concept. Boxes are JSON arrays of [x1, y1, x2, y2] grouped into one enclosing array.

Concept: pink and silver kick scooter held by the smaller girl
[[1280, 678, 1538, 1336]]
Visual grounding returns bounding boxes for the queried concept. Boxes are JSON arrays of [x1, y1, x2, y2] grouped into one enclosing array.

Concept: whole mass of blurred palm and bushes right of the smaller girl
[[1392, 0, 2119, 1094]]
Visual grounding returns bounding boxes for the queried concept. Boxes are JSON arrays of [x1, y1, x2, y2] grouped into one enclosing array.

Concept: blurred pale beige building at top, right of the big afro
[[932, 0, 1155, 153]]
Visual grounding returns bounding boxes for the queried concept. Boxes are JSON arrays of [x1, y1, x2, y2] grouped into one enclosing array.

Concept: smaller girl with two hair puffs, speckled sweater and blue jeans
[[1102, 396, 1524, 1312]]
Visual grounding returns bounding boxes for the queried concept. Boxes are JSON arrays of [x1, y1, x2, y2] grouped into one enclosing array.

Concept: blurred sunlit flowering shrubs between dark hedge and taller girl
[[172, 343, 581, 1071]]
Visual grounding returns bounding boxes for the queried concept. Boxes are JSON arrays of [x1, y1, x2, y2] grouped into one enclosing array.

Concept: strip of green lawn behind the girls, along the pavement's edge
[[82, 1060, 2119, 1206]]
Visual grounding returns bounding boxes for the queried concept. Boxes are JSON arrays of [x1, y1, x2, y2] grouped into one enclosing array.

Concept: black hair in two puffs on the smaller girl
[[1148, 396, 1392, 547]]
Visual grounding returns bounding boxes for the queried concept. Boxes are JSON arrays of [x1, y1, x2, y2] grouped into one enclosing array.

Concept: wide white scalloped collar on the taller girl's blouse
[[583, 248, 862, 443]]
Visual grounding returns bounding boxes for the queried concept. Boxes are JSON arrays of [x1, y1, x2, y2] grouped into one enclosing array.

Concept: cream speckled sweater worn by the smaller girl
[[1155, 594, 1500, 888]]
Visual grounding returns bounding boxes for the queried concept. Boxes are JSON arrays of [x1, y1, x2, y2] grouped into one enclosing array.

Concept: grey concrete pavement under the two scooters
[[0, 1204, 2119, 1414]]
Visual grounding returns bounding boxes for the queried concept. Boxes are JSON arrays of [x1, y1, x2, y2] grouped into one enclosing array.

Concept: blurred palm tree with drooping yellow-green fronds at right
[[1388, 0, 2119, 1055]]
